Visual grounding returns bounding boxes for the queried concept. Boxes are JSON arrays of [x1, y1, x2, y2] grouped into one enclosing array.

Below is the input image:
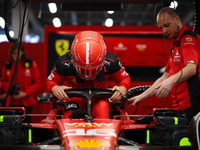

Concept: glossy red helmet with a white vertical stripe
[[71, 31, 106, 80]]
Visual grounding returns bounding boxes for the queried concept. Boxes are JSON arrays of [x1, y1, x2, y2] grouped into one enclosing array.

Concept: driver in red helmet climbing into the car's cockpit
[[46, 31, 130, 118]]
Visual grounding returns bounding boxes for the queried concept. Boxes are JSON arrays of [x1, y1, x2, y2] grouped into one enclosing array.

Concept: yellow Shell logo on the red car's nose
[[72, 139, 110, 149]]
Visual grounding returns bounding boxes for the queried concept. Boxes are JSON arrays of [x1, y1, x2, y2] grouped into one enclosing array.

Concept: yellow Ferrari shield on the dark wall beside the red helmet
[[55, 39, 69, 56]]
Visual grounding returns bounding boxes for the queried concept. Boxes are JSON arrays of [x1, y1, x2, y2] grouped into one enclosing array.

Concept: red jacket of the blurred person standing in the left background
[[1, 59, 41, 107]]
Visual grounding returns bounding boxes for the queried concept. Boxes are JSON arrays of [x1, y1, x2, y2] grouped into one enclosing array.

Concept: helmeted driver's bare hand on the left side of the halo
[[52, 85, 72, 100]]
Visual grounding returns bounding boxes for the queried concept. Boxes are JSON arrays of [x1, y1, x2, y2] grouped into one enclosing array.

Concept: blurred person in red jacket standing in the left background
[[1, 43, 41, 122]]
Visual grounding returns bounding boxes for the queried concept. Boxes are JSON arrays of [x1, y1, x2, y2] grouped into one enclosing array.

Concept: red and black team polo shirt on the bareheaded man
[[165, 26, 200, 110]]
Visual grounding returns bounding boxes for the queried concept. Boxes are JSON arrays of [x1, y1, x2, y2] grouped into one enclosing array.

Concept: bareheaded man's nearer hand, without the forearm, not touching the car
[[156, 78, 173, 98]]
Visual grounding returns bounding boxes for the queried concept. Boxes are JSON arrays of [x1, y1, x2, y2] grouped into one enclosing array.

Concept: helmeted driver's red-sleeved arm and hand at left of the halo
[[46, 70, 72, 100]]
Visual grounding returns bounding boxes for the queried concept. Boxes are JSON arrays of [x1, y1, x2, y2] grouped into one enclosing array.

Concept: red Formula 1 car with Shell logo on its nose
[[0, 86, 200, 150]]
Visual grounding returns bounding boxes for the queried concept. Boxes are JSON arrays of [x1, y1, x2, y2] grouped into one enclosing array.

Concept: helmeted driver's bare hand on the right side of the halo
[[110, 86, 126, 101]]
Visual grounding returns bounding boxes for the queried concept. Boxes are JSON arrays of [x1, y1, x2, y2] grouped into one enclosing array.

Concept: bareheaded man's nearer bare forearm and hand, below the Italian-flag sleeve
[[156, 63, 197, 98]]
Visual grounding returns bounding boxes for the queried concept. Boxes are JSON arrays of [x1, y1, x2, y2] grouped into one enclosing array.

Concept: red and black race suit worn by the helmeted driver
[[46, 51, 130, 118]]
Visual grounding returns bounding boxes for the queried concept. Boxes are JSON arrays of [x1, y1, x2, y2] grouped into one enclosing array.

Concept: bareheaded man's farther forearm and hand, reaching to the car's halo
[[128, 72, 169, 105]]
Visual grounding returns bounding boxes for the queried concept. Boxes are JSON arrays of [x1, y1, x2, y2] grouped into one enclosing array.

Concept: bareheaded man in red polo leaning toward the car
[[128, 7, 200, 124]]
